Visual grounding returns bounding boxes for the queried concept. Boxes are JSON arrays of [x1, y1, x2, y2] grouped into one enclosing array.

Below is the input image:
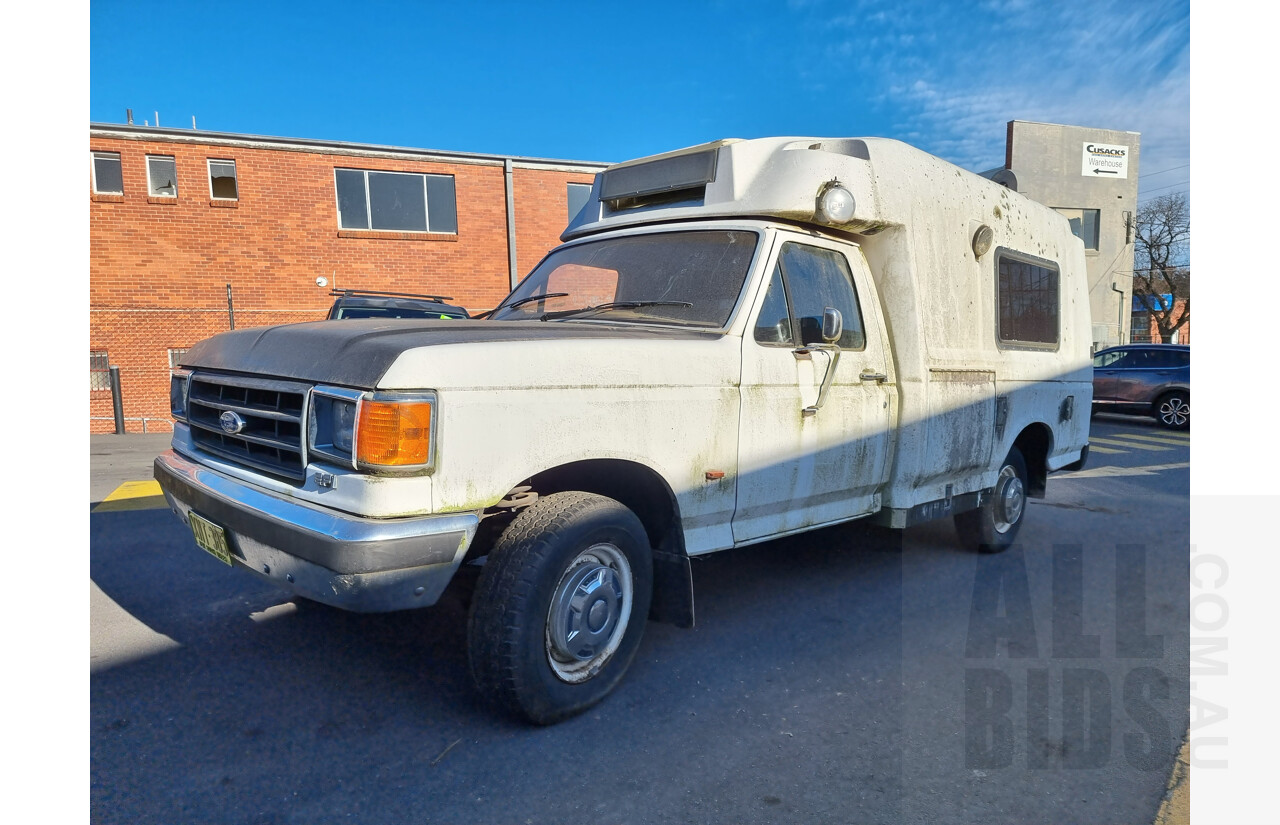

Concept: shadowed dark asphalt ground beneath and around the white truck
[[91, 416, 1189, 825]]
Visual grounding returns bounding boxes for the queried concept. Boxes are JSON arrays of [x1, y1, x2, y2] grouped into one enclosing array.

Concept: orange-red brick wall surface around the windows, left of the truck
[[90, 134, 604, 432]]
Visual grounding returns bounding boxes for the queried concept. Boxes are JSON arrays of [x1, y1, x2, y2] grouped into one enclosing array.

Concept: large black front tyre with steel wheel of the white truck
[[467, 492, 653, 725]]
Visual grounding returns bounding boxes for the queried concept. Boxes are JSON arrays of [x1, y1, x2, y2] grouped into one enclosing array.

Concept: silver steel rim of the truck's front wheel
[[544, 542, 635, 684]]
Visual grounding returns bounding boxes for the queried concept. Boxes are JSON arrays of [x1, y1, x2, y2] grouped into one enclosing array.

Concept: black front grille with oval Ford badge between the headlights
[[187, 372, 311, 481]]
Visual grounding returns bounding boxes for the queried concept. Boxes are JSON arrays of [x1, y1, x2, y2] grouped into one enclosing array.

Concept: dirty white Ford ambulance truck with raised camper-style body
[[155, 138, 1092, 723]]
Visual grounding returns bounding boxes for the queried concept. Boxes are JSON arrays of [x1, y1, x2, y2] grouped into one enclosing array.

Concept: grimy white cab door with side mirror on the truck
[[733, 232, 893, 544]]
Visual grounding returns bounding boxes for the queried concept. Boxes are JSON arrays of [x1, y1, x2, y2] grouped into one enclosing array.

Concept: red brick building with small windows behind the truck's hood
[[90, 124, 604, 432]]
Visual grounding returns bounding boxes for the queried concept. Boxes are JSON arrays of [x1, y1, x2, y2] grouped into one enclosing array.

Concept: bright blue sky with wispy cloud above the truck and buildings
[[90, 0, 1190, 196]]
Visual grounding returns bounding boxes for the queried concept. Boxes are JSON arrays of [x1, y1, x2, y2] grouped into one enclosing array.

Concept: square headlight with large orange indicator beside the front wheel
[[307, 386, 435, 469]]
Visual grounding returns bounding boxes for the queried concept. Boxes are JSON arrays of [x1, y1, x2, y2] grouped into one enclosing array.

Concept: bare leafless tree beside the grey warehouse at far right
[[1133, 192, 1192, 344]]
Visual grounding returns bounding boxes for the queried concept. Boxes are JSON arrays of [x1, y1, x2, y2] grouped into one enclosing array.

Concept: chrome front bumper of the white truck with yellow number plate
[[155, 450, 480, 613]]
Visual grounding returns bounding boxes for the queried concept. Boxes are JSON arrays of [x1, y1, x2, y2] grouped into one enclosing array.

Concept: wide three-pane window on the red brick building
[[333, 169, 458, 234]]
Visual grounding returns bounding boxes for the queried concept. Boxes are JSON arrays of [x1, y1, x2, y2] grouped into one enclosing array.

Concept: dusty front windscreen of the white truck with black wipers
[[492, 229, 759, 329]]
